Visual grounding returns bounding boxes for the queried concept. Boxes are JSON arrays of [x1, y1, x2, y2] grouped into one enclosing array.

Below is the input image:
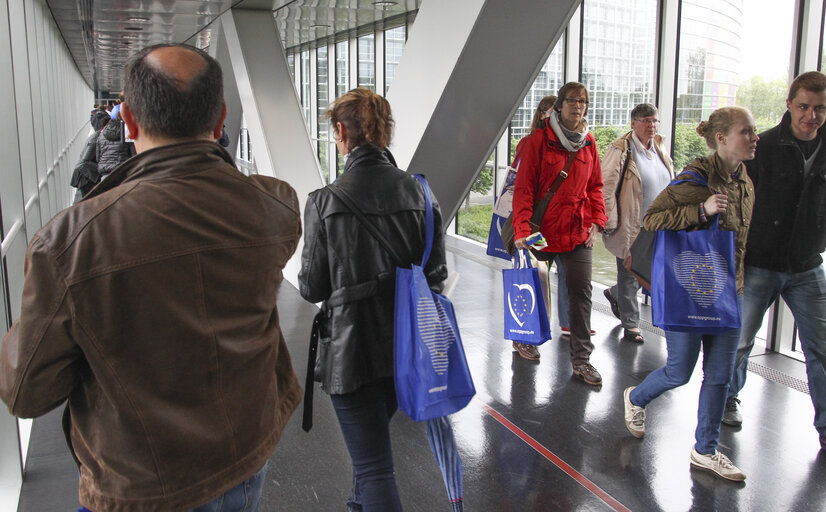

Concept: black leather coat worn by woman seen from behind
[[298, 146, 447, 394]]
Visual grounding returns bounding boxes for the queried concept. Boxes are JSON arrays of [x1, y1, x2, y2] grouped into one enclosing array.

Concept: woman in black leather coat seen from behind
[[298, 88, 447, 512]]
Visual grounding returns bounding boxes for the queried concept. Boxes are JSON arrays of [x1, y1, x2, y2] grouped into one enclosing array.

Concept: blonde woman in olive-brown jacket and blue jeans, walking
[[624, 107, 759, 481]]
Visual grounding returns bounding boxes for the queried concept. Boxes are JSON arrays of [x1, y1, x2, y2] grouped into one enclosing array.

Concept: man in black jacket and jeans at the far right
[[723, 71, 826, 448]]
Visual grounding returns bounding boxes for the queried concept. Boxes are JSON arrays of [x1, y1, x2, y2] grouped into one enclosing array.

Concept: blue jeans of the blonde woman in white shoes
[[630, 320, 740, 454]]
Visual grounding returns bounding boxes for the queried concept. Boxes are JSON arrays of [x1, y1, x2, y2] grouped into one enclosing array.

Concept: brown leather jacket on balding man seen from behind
[[0, 141, 301, 512]]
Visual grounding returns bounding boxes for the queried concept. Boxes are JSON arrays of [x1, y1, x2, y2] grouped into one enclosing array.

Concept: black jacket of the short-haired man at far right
[[746, 111, 826, 272]]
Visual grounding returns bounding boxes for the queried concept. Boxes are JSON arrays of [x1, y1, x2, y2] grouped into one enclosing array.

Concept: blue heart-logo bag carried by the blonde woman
[[651, 217, 740, 334]]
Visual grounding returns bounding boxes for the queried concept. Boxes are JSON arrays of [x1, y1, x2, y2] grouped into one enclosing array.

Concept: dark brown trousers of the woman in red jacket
[[541, 245, 594, 365]]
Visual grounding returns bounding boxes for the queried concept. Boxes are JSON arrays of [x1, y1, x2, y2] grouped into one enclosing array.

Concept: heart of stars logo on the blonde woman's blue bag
[[671, 251, 729, 308]]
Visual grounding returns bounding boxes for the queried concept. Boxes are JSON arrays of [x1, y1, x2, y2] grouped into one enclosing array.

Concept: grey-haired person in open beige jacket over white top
[[602, 103, 674, 343]]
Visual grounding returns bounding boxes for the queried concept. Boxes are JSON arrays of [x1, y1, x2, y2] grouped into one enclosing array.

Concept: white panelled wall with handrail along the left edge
[[0, 0, 94, 510]]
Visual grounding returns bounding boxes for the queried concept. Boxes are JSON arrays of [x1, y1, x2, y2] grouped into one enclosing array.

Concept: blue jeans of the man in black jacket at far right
[[729, 266, 826, 436]]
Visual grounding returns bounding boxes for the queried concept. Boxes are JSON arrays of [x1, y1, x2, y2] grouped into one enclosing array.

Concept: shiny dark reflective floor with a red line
[[14, 240, 826, 512]]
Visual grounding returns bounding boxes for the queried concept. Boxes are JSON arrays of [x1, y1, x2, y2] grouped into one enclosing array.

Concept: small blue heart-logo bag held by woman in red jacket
[[502, 249, 551, 345]]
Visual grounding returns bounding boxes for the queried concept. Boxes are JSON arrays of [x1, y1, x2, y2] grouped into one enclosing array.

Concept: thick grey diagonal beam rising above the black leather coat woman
[[387, 0, 581, 225]]
